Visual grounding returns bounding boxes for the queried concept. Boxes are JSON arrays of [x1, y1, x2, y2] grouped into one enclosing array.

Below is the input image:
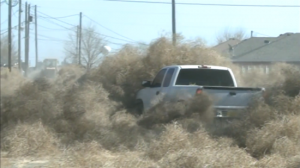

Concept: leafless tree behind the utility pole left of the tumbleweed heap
[[65, 27, 106, 70]]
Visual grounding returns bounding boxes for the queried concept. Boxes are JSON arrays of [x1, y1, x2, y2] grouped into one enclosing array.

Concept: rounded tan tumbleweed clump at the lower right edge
[[246, 115, 300, 158]]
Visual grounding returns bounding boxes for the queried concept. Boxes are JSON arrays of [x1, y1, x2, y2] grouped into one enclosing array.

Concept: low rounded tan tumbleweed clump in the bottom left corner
[[1, 121, 59, 157]]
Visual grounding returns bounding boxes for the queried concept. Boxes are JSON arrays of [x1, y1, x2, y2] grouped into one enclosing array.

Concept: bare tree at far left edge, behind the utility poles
[[0, 35, 18, 65]]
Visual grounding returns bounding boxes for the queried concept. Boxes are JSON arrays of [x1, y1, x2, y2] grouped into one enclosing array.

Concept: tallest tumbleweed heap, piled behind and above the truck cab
[[89, 37, 239, 107]]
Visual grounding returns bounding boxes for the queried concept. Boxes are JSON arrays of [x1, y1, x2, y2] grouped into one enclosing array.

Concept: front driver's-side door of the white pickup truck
[[144, 69, 167, 107]]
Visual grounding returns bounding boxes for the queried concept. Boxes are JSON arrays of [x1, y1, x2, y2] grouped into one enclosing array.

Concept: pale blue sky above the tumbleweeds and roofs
[[1, 0, 300, 66]]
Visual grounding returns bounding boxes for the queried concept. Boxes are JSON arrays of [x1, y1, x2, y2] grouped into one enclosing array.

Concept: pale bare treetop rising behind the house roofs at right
[[216, 28, 249, 44]]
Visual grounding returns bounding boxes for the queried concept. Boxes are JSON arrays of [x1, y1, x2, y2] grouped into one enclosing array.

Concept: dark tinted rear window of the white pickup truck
[[176, 69, 234, 86]]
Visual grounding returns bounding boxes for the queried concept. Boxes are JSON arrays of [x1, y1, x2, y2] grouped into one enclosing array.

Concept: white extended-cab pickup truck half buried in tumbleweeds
[[135, 65, 265, 118]]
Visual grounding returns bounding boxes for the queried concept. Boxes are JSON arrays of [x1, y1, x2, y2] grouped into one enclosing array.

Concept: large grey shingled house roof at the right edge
[[231, 33, 300, 62]]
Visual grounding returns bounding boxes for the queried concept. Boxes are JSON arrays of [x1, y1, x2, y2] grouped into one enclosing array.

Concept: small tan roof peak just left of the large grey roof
[[212, 38, 241, 57]]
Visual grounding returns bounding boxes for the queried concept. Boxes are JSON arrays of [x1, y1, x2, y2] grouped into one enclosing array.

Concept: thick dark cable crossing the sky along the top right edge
[[104, 0, 300, 8]]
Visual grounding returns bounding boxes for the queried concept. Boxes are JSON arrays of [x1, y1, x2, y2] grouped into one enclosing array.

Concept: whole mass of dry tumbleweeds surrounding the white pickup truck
[[1, 37, 300, 168]]
